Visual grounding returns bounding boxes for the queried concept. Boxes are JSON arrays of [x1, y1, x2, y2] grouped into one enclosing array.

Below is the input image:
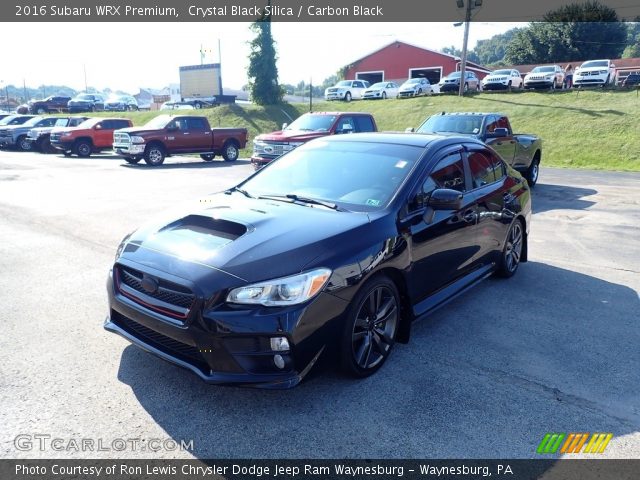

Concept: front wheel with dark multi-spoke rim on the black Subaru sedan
[[340, 275, 400, 378]]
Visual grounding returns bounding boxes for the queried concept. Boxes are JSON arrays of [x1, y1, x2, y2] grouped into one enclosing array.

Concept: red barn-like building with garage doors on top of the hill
[[344, 41, 490, 84]]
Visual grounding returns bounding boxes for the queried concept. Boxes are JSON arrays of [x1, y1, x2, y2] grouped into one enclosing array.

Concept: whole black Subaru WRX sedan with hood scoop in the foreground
[[105, 133, 531, 388]]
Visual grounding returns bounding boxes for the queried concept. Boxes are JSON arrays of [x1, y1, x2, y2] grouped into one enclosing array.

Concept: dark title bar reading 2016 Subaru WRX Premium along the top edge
[[0, 0, 640, 22]]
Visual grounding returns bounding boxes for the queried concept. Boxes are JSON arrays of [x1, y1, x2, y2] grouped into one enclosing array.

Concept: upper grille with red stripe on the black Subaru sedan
[[116, 265, 196, 320]]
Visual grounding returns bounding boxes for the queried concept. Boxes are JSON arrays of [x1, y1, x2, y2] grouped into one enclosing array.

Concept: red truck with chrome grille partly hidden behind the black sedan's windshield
[[251, 112, 378, 170]]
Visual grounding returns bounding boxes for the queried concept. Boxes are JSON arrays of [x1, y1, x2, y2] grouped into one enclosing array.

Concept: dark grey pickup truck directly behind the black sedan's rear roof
[[415, 112, 542, 187]]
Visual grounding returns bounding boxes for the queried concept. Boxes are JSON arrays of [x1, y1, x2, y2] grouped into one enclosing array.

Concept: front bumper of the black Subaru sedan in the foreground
[[104, 264, 348, 389]]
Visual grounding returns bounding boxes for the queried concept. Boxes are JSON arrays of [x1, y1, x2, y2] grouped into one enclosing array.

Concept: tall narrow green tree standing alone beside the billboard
[[247, 16, 284, 105]]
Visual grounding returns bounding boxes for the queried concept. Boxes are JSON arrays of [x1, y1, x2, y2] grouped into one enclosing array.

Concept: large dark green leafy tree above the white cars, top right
[[505, 2, 627, 64]]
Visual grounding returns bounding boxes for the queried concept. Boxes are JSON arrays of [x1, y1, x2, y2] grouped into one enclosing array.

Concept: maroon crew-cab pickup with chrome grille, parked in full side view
[[113, 115, 248, 166]]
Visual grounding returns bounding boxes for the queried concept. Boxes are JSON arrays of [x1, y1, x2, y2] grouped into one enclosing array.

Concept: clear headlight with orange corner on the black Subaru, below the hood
[[227, 268, 331, 307]]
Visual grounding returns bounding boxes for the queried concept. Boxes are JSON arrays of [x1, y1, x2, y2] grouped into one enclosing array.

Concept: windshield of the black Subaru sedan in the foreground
[[241, 139, 423, 211]]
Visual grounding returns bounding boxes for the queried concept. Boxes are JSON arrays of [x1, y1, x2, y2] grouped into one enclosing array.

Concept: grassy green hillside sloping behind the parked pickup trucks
[[91, 90, 640, 171]]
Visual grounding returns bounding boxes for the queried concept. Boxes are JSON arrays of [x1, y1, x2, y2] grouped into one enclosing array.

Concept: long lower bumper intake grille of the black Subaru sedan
[[111, 310, 210, 372]]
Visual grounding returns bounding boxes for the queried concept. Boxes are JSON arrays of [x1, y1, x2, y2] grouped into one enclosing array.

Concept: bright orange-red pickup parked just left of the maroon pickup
[[49, 118, 132, 157]]
